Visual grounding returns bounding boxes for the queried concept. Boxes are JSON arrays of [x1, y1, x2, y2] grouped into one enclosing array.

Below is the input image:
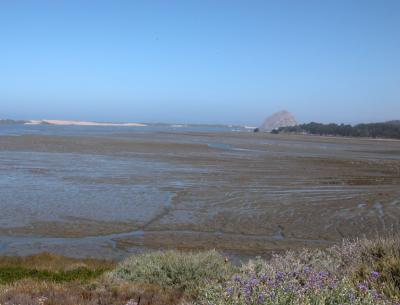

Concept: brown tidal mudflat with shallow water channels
[[0, 126, 400, 258]]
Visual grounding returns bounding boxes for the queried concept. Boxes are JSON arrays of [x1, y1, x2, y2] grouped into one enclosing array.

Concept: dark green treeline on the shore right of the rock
[[272, 121, 400, 139]]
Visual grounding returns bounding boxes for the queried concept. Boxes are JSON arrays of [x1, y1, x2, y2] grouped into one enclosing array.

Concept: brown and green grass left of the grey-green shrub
[[0, 253, 183, 305]]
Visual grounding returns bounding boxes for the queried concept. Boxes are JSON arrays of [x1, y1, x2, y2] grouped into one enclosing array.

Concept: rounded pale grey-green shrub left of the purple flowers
[[109, 251, 234, 297]]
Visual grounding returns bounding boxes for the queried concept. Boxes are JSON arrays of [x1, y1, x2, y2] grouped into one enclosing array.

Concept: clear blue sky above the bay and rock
[[0, 0, 400, 125]]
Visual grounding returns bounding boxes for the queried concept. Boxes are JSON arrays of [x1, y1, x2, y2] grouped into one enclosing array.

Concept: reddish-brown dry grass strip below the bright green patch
[[0, 280, 183, 305]]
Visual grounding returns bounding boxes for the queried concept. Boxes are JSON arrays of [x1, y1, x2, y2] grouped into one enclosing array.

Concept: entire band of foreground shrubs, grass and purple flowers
[[0, 237, 400, 305]]
